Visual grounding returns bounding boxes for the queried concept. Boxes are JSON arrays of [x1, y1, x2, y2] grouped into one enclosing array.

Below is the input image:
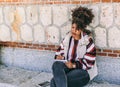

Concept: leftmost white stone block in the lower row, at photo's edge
[[0, 25, 11, 41]]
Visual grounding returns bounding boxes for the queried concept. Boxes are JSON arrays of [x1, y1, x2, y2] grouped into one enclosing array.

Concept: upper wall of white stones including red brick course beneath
[[0, 2, 120, 57]]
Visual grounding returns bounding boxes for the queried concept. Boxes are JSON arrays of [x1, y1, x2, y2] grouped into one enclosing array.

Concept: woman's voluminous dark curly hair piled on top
[[72, 6, 94, 34]]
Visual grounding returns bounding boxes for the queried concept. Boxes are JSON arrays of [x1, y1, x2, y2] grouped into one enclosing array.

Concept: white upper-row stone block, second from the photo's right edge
[[100, 4, 113, 28]]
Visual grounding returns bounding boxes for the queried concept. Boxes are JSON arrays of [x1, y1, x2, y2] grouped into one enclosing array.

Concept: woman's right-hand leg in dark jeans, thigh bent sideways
[[67, 69, 90, 87]]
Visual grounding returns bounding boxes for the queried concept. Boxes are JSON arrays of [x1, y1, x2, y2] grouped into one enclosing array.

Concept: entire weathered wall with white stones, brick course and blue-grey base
[[0, 0, 120, 84]]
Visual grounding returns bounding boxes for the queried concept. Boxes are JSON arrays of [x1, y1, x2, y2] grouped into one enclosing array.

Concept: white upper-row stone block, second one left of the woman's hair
[[39, 5, 52, 26]]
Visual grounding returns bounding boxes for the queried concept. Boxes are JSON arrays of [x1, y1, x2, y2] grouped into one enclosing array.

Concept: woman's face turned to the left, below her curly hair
[[71, 23, 81, 38]]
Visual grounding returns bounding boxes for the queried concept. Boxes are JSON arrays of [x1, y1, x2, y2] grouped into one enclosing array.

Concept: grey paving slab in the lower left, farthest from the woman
[[0, 66, 40, 87]]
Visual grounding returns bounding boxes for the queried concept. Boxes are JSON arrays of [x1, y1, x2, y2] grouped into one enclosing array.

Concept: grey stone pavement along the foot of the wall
[[0, 65, 120, 87]]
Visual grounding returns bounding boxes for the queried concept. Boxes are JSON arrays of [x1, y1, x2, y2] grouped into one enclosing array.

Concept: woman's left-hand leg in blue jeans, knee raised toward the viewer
[[52, 61, 67, 87]]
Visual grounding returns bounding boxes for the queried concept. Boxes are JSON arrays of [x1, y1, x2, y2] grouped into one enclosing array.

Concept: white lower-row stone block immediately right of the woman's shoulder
[[95, 27, 107, 47]]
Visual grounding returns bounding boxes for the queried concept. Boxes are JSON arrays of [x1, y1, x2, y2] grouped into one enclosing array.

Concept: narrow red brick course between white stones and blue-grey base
[[0, 42, 120, 58]]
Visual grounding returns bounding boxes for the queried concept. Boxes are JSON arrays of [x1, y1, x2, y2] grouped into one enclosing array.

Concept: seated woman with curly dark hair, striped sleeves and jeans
[[51, 7, 97, 87]]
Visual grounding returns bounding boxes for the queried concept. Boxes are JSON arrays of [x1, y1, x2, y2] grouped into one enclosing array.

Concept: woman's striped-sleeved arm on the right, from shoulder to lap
[[75, 38, 96, 70]]
